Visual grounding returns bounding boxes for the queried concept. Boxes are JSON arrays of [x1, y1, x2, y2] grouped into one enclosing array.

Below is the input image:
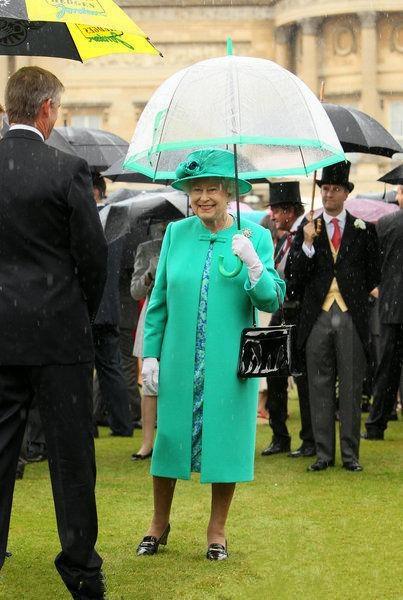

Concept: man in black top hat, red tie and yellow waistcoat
[[286, 162, 380, 472]]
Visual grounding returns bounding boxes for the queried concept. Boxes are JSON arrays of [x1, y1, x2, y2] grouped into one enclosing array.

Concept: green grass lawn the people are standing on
[[0, 400, 403, 600]]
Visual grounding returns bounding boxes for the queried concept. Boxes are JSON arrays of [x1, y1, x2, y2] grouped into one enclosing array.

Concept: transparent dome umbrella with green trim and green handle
[[124, 48, 345, 276]]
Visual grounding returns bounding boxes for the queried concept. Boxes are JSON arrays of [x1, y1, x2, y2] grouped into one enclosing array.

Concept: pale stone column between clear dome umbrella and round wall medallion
[[298, 17, 322, 95]]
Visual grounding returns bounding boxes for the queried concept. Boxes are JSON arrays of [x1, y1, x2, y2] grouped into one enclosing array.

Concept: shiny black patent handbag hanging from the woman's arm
[[238, 290, 300, 379]]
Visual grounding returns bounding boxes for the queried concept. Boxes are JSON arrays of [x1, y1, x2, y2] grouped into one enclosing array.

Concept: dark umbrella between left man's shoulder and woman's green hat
[[99, 191, 189, 243]]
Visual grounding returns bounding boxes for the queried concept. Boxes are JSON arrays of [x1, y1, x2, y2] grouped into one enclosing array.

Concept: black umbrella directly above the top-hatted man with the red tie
[[323, 102, 403, 158]]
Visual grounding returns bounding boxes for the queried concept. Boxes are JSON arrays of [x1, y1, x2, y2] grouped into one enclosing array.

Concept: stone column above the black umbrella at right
[[359, 11, 379, 119]]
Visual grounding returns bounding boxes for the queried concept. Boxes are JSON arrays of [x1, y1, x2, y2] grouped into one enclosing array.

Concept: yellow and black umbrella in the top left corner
[[0, 0, 160, 61]]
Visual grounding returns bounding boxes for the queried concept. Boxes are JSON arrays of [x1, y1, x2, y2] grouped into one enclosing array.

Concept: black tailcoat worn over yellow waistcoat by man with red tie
[[286, 212, 380, 348]]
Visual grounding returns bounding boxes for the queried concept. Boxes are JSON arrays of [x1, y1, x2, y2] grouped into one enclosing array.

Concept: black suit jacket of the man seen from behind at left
[[0, 130, 107, 365]]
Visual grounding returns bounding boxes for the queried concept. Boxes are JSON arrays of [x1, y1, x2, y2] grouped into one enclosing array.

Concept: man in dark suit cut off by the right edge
[[363, 185, 403, 440]]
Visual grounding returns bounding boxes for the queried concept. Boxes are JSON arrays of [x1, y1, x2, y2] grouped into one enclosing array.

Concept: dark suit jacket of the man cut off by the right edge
[[376, 209, 403, 324]]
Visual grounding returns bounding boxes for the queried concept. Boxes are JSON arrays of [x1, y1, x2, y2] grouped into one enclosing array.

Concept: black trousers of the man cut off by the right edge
[[365, 323, 403, 434]]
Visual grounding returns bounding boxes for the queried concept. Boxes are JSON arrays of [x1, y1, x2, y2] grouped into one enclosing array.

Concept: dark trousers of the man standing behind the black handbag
[[266, 308, 315, 448]]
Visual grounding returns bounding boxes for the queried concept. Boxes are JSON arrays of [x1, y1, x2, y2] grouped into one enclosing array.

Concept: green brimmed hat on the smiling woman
[[171, 148, 252, 195]]
